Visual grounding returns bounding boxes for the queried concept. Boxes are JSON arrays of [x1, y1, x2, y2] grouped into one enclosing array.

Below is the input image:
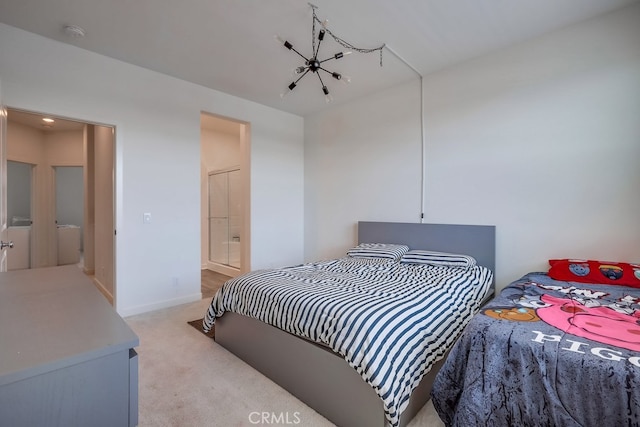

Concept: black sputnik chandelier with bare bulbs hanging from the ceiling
[[276, 3, 384, 102]]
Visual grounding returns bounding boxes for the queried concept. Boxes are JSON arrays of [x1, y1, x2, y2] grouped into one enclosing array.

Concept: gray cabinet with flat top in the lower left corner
[[0, 265, 139, 427]]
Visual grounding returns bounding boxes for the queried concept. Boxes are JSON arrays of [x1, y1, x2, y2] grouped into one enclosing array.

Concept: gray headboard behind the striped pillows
[[358, 221, 496, 281]]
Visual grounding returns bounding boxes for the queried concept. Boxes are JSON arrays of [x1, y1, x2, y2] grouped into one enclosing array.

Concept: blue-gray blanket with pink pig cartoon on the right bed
[[432, 273, 640, 427]]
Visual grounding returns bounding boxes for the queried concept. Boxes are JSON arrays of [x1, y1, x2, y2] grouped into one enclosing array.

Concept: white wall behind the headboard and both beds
[[305, 6, 640, 288]]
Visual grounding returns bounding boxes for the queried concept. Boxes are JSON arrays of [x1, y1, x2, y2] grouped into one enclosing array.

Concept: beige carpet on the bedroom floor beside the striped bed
[[125, 299, 443, 427]]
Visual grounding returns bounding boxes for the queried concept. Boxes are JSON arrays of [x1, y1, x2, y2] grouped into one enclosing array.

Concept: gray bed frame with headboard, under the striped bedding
[[215, 222, 495, 427]]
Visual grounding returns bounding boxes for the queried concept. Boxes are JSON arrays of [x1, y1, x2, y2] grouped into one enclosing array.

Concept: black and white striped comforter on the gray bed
[[203, 257, 493, 426]]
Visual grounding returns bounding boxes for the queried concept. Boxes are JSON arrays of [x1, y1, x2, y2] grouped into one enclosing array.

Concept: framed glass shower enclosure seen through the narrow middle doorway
[[209, 168, 242, 269]]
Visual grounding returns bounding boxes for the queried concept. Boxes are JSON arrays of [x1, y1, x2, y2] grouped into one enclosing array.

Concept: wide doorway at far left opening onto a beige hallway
[[2, 108, 115, 304]]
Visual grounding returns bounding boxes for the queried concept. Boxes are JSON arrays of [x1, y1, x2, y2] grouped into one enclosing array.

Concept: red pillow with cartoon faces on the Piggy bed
[[548, 259, 640, 288]]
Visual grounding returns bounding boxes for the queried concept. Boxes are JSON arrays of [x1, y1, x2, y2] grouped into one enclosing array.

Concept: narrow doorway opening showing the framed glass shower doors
[[200, 113, 250, 277]]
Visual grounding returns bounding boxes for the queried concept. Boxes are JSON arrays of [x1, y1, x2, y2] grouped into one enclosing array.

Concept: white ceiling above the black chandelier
[[0, 0, 639, 116]]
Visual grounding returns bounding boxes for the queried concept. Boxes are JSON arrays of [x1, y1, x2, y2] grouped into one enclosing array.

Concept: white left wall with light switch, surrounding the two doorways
[[0, 24, 303, 315]]
